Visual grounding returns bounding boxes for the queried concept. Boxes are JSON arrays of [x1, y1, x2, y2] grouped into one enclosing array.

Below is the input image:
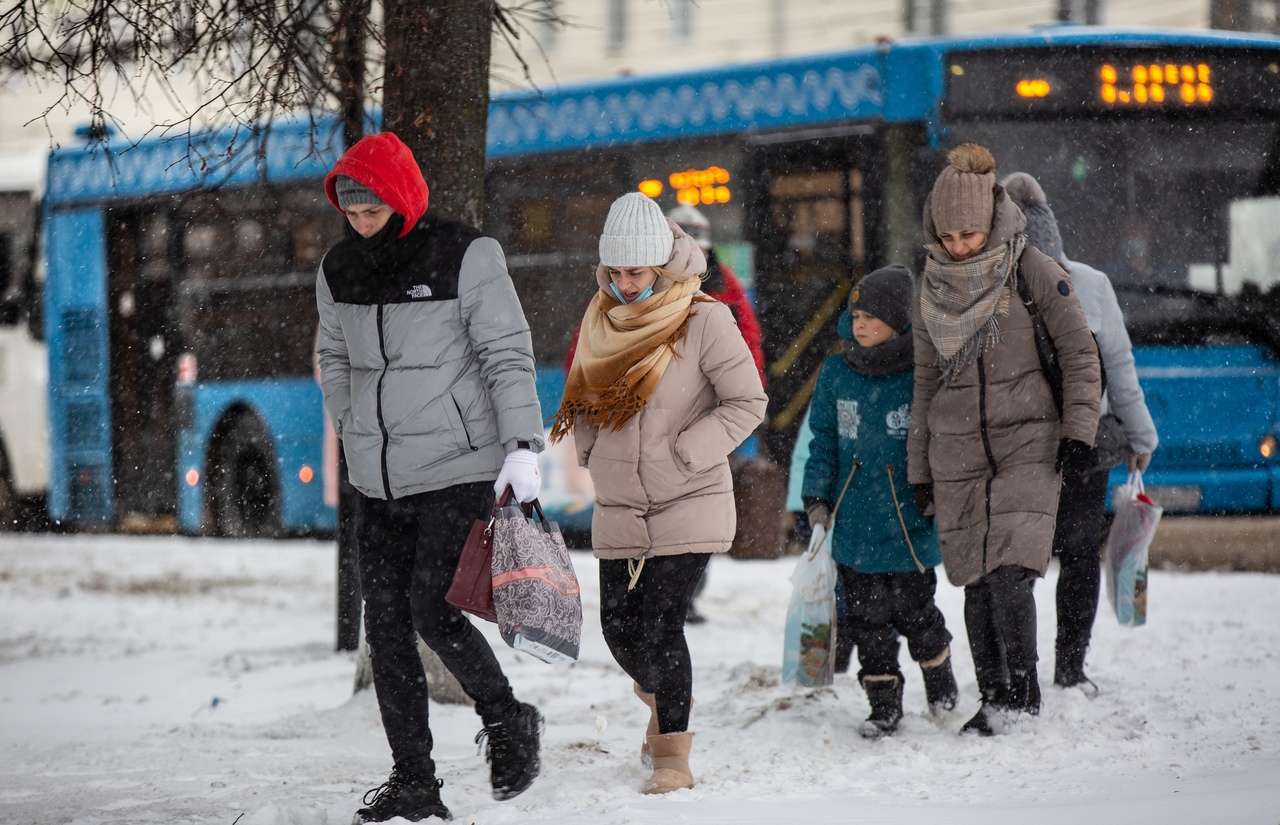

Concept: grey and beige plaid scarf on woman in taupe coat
[[920, 233, 1027, 384]]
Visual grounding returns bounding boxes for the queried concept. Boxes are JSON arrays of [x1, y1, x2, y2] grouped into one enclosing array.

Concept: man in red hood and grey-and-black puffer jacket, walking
[[316, 132, 543, 822]]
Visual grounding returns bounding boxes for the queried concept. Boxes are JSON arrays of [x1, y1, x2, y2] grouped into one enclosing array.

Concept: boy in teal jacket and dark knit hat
[[801, 265, 956, 738]]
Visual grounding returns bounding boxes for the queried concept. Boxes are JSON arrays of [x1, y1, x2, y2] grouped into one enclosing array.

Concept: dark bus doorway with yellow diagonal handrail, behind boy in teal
[[746, 129, 876, 466]]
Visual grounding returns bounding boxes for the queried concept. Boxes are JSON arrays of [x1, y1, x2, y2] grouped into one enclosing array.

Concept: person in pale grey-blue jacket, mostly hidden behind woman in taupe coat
[[1002, 171, 1160, 695]]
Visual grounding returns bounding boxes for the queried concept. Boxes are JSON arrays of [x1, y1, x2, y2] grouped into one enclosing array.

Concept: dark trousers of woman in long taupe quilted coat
[[964, 564, 1038, 697]]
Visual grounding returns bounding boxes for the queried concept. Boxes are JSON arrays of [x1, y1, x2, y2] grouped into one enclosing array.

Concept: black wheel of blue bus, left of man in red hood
[[210, 416, 280, 538]]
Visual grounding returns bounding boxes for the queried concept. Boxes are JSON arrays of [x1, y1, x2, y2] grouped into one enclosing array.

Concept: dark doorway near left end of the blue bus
[[106, 210, 180, 528]]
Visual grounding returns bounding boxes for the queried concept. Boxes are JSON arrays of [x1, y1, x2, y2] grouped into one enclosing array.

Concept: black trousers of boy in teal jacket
[[836, 564, 951, 680]]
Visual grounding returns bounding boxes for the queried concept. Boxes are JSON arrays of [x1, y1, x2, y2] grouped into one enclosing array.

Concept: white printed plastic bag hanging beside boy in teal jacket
[[782, 524, 836, 687]]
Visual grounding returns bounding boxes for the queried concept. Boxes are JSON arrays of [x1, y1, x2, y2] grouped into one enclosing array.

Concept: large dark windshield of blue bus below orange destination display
[[952, 119, 1280, 295]]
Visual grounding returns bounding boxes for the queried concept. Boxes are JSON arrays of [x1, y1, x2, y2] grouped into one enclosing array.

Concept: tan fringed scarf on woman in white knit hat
[[550, 278, 710, 443]]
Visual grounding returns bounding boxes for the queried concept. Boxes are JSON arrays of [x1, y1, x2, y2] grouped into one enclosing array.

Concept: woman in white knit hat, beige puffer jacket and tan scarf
[[550, 192, 767, 793]]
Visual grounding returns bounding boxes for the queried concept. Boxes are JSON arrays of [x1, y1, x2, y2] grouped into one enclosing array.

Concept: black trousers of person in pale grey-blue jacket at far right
[[1053, 457, 1108, 668]]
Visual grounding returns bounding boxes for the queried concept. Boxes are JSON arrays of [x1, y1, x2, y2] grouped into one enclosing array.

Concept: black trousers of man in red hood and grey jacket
[[356, 481, 518, 765]]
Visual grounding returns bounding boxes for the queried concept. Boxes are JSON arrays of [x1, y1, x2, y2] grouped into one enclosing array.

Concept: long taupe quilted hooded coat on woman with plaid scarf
[[908, 185, 1101, 586]]
